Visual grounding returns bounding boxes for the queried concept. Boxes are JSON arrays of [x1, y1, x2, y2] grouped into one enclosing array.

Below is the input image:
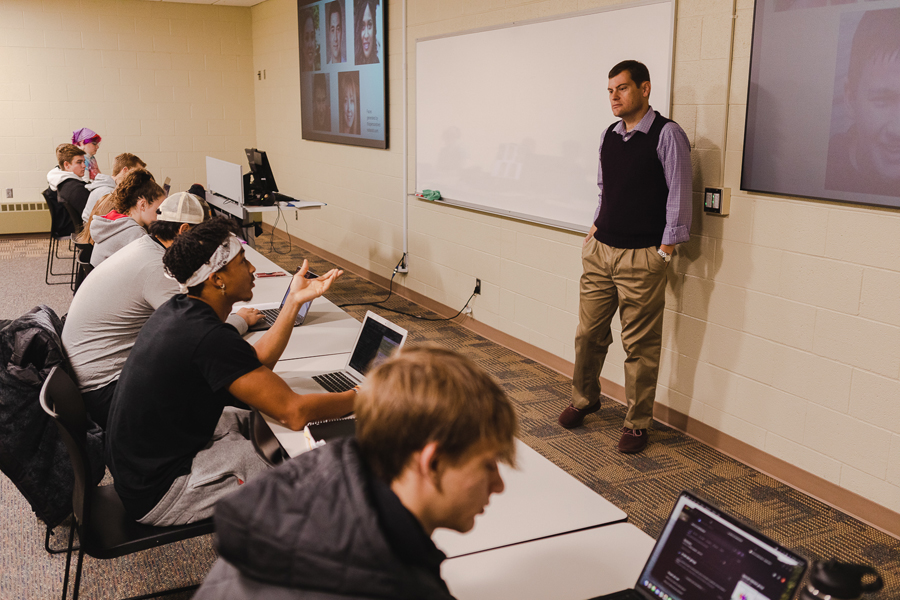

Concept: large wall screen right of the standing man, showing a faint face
[[741, 0, 900, 208]]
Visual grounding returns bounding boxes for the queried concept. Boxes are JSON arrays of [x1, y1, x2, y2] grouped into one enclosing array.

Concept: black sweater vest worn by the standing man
[[594, 113, 669, 248]]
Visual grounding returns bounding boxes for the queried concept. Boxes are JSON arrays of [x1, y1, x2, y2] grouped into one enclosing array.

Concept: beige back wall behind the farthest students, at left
[[0, 0, 256, 218]]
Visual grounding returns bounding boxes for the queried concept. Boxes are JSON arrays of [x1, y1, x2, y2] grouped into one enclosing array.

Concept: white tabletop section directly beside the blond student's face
[[433, 440, 628, 557]]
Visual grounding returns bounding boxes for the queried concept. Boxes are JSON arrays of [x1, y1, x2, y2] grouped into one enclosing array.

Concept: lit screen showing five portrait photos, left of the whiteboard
[[297, 0, 387, 148]]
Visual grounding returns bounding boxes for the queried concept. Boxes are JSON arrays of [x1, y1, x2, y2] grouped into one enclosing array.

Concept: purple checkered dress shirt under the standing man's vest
[[594, 107, 693, 246]]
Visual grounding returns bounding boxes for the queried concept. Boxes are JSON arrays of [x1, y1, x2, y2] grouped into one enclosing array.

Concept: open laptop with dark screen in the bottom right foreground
[[591, 492, 807, 600]]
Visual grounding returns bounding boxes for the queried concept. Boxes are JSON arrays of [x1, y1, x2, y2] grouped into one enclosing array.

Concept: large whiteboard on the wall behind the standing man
[[416, 0, 674, 231]]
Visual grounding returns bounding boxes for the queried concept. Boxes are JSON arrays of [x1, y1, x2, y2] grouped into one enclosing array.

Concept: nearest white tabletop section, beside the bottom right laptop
[[441, 523, 654, 600]]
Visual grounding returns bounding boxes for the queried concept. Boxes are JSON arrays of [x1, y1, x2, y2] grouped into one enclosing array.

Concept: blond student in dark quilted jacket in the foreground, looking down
[[194, 347, 516, 600]]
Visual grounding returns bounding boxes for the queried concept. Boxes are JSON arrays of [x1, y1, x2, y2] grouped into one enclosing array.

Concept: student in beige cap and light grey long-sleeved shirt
[[62, 192, 260, 429]]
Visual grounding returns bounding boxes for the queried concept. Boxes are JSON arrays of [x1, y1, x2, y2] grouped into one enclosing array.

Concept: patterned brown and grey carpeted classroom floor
[[0, 234, 900, 599]]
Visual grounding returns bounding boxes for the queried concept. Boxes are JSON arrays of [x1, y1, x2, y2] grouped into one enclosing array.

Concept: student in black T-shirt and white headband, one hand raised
[[106, 217, 356, 526]]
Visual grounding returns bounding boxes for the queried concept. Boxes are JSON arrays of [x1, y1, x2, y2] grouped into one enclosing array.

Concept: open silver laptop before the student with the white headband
[[313, 311, 408, 392]]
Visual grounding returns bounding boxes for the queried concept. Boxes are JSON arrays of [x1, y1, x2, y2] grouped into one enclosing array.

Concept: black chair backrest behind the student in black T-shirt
[[41, 366, 93, 528]]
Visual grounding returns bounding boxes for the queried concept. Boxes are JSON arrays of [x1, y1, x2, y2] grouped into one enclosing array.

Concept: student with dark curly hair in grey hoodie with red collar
[[90, 169, 166, 267]]
